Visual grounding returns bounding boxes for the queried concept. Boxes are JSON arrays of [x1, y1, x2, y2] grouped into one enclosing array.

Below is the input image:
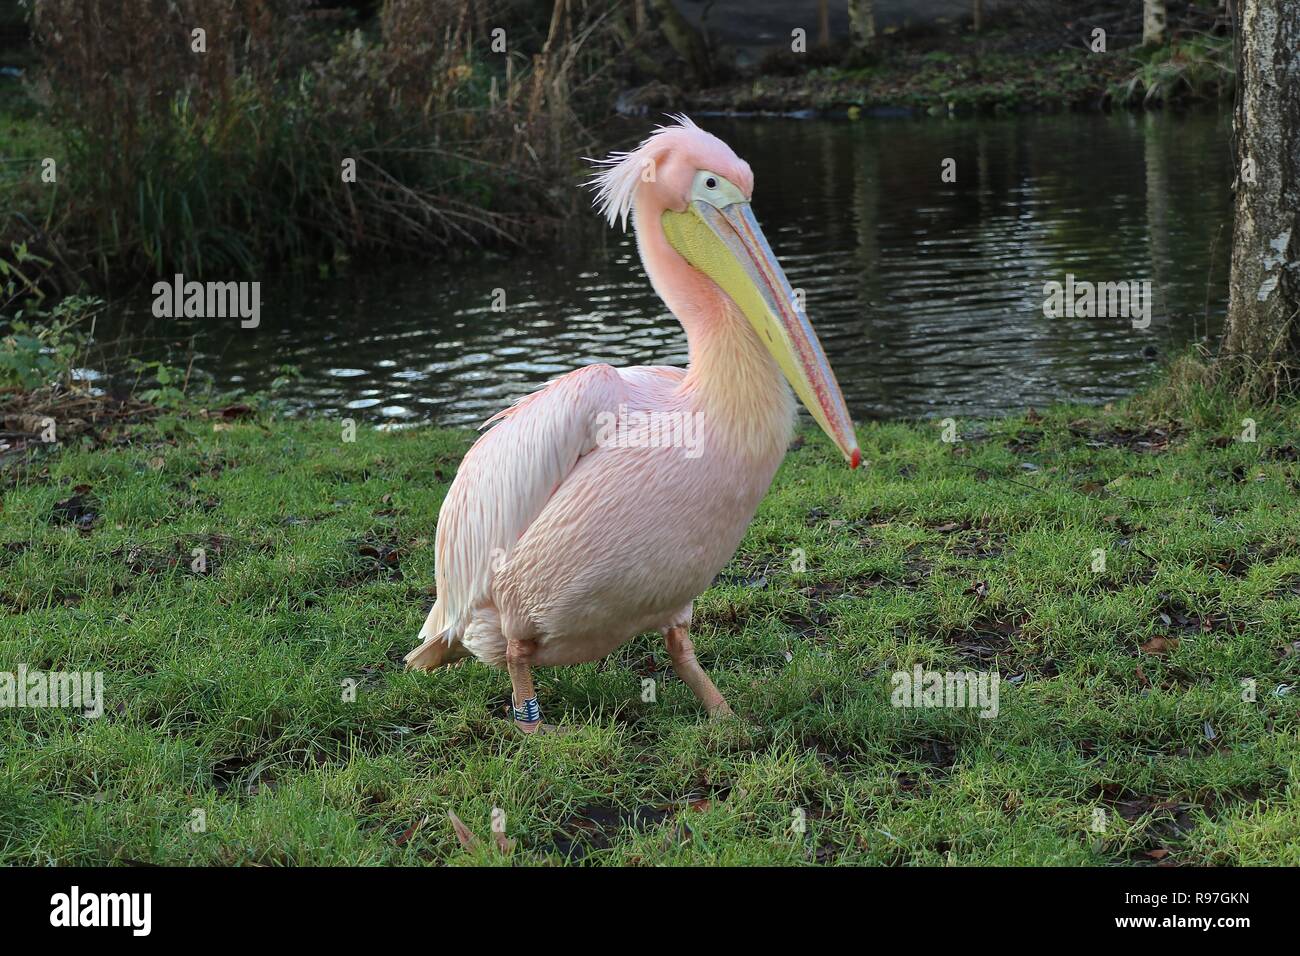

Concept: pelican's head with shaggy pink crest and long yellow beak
[[589, 116, 862, 468]]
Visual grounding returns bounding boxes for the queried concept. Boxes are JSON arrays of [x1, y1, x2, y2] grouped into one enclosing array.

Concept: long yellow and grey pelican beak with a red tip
[[663, 199, 862, 468]]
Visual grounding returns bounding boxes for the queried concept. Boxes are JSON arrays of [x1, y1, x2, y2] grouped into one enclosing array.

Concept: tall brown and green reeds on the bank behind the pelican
[[19, 0, 612, 285]]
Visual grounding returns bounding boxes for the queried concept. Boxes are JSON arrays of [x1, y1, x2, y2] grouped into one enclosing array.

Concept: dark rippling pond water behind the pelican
[[98, 114, 1231, 424]]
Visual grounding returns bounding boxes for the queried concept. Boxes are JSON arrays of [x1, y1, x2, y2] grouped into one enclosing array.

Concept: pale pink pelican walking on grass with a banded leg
[[406, 116, 862, 734]]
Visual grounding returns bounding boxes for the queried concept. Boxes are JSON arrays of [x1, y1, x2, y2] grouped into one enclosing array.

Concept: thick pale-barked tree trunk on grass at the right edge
[[1217, 0, 1300, 397]]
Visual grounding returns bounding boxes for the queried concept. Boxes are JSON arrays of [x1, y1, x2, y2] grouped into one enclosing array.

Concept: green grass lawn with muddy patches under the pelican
[[0, 392, 1300, 865]]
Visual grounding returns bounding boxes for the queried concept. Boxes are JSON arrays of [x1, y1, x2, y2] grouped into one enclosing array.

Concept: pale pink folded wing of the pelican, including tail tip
[[406, 365, 628, 667]]
